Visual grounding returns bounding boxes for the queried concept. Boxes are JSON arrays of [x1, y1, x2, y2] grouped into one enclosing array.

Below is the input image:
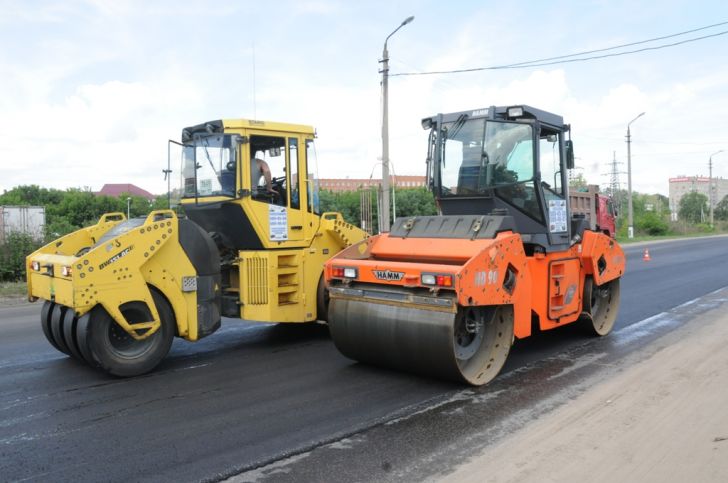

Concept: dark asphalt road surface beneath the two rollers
[[0, 237, 728, 482]]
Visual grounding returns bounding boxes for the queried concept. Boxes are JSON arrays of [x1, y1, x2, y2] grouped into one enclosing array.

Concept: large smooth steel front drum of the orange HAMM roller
[[329, 296, 513, 386]]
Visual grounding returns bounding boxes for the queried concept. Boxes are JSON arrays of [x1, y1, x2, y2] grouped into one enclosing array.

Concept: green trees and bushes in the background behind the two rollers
[[0, 182, 728, 280]]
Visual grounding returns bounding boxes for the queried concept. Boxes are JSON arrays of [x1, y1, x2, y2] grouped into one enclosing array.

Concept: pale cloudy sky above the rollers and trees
[[0, 0, 728, 194]]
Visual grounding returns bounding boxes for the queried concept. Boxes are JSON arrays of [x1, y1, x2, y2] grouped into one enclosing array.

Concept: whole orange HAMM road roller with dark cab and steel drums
[[325, 105, 625, 385]]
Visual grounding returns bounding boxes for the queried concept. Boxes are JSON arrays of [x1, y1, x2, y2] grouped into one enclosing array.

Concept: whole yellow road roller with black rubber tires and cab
[[27, 120, 366, 376]]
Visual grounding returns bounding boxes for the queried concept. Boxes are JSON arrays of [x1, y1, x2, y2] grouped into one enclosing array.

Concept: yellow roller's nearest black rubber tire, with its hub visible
[[86, 290, 175, 377]]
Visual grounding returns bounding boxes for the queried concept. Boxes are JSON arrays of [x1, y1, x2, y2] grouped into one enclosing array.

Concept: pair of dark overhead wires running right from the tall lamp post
[[389, 22, 728, 77]]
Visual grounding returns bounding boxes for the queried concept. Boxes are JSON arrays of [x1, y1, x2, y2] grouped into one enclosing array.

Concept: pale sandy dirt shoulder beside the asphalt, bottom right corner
[[443, 311, 728, 483]]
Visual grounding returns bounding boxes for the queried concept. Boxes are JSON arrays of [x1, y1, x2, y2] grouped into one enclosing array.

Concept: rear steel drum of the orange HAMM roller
[[581, 277, 620, 336]]
